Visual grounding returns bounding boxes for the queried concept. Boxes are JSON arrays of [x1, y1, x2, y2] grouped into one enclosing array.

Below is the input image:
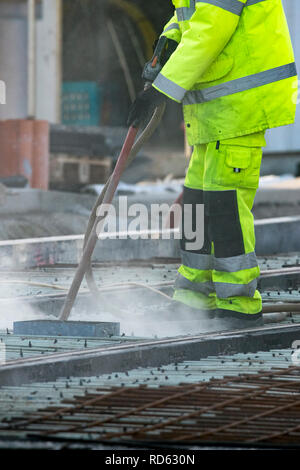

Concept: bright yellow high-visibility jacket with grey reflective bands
[[153, 0, 298, 145]]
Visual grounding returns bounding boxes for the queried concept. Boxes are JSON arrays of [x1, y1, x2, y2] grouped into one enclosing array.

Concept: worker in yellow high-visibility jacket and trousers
[[129, 0, 298, 328]]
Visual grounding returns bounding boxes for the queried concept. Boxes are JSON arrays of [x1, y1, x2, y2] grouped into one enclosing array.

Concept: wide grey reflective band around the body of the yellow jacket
[[183, 62, 297, 105]]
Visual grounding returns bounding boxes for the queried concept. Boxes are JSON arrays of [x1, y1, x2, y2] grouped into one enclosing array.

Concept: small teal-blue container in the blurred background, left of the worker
[[62, 82, 102, 126]]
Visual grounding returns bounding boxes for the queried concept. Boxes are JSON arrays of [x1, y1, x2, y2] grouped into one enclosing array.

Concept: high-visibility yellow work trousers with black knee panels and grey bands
[[174, 133, 265, 315]]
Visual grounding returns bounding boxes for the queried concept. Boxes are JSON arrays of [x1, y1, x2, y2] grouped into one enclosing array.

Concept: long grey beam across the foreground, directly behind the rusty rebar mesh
[[0, 324, 300, 386]]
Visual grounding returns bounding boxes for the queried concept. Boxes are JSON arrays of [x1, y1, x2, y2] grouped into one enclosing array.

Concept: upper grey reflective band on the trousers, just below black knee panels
[[181, 250, 258, 273]]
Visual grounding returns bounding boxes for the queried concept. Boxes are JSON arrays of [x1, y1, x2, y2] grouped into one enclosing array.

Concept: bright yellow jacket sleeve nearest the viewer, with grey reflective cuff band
[[153, 0, 246, 102]]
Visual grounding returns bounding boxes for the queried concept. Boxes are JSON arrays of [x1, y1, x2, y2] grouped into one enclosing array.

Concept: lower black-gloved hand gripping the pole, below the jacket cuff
[[127, 86, 167, 127]]
